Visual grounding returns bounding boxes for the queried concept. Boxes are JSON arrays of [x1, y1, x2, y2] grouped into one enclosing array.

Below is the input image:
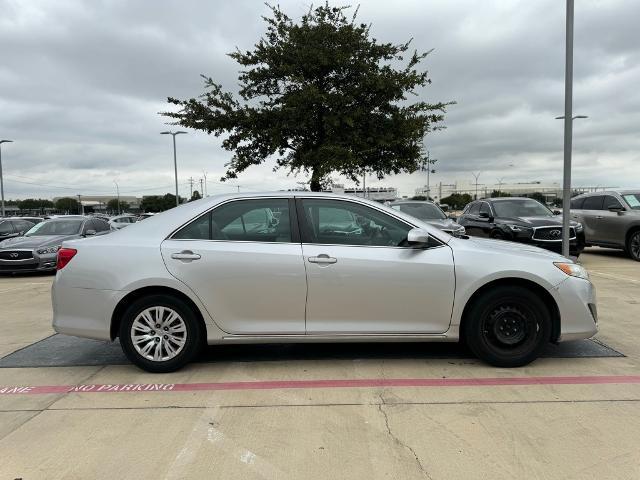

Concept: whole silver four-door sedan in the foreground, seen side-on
[[52, 192, 597, 372]]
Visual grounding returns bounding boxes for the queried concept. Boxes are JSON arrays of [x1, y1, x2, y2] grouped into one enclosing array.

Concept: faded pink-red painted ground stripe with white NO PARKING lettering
[[0, 375, 640, 396]]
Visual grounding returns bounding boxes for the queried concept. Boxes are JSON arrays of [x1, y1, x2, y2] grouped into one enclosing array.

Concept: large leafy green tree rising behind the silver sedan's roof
[[163, 3, 448, 191]]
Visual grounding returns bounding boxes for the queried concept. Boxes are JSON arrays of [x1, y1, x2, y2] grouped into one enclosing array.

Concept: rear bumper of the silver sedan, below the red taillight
[[51, 282, 127, 341]]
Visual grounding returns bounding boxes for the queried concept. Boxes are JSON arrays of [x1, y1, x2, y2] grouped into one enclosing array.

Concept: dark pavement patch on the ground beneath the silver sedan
[[0, 335, 624, 368]]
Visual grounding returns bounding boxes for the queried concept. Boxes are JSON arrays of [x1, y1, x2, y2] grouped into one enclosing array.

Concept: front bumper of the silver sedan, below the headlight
[[551, 277, 598, 342]]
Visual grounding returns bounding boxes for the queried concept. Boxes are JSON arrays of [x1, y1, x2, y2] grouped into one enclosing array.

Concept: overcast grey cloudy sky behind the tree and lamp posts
[[0, 0, 640, 198]]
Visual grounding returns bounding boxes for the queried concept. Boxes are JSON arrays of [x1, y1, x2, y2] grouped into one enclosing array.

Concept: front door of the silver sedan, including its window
[[297, 198, 455, 335]]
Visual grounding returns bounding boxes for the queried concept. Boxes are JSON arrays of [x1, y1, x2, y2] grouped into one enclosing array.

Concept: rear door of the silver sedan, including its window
[[161, 197, 307, 334]]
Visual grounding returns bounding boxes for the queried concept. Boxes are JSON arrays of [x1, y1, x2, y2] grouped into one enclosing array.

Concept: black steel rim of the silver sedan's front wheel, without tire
[[482, 302, 540, 353]]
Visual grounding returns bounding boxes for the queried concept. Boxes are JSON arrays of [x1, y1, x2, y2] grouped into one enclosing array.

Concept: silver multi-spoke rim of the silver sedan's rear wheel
[[130, 306, 187, 362]]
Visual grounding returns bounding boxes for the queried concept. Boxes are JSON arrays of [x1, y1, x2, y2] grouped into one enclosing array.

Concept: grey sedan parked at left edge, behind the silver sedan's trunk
[[0, 215, 109, 273]]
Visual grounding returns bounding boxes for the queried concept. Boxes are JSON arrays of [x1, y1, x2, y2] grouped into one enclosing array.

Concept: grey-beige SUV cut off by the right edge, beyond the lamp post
[[571, 190, 640, 262]]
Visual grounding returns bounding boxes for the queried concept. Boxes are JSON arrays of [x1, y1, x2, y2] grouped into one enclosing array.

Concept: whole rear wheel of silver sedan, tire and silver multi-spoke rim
[[119, 295, 204, 373]]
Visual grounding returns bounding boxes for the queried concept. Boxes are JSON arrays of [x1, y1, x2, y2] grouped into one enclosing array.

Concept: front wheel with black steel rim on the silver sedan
[[462, 286, 551, 368]]
